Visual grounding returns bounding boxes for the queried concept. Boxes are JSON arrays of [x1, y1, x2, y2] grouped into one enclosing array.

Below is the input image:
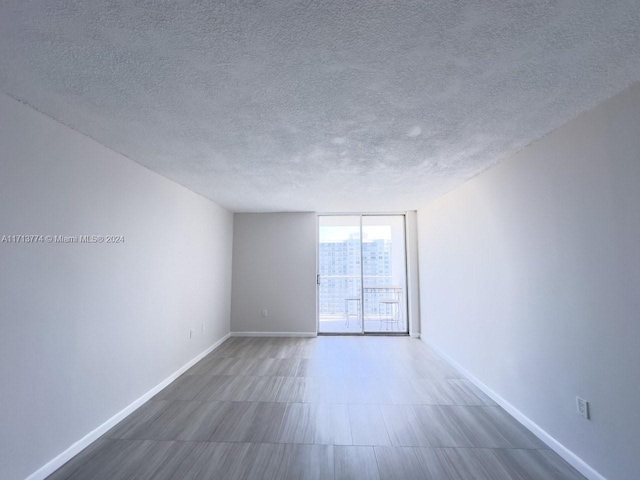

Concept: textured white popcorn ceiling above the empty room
[[0, 0, 640, 211]]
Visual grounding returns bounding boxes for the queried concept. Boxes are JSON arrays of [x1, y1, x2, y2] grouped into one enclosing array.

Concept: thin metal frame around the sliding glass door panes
[[316, 212, 410, 336]]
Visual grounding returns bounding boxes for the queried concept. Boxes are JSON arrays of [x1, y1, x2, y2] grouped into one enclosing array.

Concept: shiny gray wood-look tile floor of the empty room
[[49, 337, 584, 480]]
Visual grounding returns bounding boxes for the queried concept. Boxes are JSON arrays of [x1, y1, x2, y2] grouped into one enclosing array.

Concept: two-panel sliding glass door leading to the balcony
[[318, 215, 408, 334]]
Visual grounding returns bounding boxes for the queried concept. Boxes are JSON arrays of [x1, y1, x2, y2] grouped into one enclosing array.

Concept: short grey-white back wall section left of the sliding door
[[231, 213, 317, 334]]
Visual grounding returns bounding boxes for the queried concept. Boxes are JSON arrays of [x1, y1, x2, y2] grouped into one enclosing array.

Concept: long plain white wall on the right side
[[418, 84, 640, 480]]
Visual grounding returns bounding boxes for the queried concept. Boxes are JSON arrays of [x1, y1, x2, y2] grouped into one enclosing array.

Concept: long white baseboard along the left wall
[[26, 333, 231, 480]]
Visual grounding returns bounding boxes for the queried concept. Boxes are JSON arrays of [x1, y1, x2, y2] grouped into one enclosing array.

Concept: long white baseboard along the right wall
[[422, 338, 607, 480]]
